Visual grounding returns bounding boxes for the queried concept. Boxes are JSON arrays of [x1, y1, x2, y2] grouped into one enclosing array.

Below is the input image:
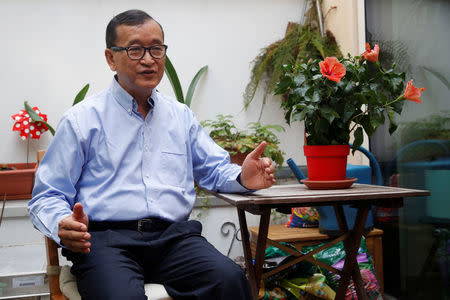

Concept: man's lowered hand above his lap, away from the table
[[58, 203, 91, 253]]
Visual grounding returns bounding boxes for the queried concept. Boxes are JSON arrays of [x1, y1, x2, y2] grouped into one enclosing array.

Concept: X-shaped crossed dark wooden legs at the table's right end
[[334, 205, 370, 300]]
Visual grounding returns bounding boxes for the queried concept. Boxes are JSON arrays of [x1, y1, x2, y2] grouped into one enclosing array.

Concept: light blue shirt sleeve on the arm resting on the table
[[189, 111, 253, 193]]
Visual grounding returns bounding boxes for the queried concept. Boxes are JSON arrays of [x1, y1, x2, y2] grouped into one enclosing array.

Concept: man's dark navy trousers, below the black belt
[[63, 221, 251, 300]]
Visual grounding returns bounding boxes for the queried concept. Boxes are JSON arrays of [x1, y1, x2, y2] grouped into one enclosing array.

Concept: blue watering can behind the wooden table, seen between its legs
[[287, 147, 382, 236]]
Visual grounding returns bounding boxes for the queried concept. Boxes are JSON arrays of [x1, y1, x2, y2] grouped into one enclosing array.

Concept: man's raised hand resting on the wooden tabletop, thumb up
[[241, 142, 275, 189]]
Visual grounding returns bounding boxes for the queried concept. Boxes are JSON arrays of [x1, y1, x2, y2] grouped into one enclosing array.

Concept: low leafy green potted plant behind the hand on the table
[[201, 115, 284, 166]]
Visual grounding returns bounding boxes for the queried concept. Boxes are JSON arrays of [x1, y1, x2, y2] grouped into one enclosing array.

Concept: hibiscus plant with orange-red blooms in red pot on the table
[[275, 44, 425, 185]]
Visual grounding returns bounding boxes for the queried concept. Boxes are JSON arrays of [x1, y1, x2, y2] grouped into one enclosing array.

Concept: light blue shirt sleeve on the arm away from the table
[[28, 114, 84, 244]]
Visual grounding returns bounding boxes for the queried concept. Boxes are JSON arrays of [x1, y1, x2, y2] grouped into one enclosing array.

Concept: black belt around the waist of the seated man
[[89, 218, 172, 232]]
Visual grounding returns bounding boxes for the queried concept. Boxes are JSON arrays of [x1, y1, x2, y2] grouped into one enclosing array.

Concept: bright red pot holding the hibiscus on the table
[[303, 145, 350, 181]]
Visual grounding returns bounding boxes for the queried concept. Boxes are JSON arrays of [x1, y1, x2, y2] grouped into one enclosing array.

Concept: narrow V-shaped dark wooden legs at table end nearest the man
[[237, 208, 270, 300]]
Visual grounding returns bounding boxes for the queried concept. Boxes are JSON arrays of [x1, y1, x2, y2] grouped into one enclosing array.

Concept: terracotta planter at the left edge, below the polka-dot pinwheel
[[0, 163, 38, 200]]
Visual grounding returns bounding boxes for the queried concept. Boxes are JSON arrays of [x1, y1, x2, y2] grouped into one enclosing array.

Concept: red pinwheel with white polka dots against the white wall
[[11, 106, 48, 140]]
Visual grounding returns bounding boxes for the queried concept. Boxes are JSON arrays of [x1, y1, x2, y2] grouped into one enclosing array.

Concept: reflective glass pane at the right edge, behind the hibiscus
[[365, 0, 450, 299]]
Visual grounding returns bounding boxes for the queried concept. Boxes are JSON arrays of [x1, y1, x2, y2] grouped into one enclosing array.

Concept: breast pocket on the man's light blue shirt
[[159, 151, 187, 188]]
